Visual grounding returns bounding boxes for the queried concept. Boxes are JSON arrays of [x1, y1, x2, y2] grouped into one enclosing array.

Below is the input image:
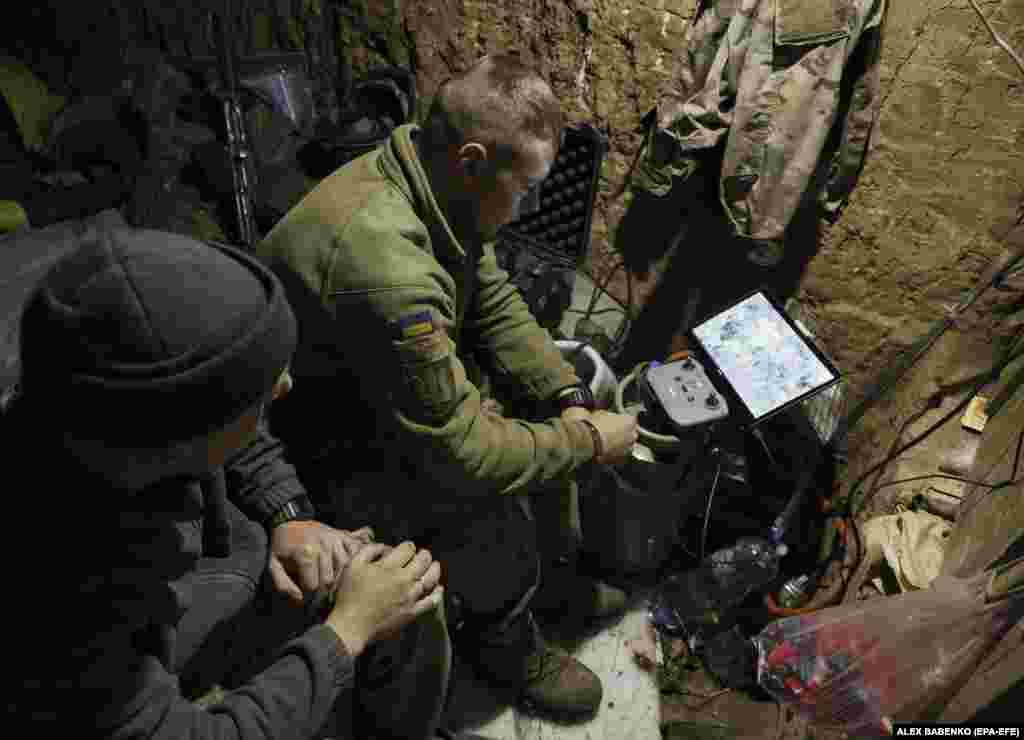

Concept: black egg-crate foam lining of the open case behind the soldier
[[495, 124, 608, 329]]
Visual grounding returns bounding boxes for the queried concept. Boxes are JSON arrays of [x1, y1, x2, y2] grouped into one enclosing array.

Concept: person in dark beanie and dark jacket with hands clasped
[[0, 225, 466, 739]]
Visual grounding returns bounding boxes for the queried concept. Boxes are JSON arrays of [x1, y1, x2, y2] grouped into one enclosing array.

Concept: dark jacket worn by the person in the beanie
[[0, 402, 353, 740]]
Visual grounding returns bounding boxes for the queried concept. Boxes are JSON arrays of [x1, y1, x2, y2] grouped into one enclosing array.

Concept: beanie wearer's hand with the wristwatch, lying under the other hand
[[267, 521, 374, 605]]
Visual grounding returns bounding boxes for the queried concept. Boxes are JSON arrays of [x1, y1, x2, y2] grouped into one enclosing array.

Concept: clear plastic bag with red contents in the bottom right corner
[[755, 572, 1024, 736]]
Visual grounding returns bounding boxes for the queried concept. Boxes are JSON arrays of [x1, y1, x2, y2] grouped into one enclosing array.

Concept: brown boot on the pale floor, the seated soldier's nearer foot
[[466, 611, 602, 716]]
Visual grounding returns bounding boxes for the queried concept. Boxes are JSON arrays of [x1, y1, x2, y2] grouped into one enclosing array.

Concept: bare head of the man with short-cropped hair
[[417, 54, 565, 242]]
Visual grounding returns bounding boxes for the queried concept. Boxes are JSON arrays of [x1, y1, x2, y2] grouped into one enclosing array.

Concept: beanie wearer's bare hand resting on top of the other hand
[[327, 542, 443, 656]]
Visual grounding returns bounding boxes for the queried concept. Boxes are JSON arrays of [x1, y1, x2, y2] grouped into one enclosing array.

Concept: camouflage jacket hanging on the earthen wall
[[634, 0, 888, 264]]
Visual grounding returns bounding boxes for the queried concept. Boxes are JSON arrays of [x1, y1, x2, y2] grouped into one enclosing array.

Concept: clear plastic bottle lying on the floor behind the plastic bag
[[650, 537, 786, 633]]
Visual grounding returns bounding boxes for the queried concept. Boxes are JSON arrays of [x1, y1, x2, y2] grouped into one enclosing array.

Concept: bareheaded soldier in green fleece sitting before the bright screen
[[258, 56, 637, 714]]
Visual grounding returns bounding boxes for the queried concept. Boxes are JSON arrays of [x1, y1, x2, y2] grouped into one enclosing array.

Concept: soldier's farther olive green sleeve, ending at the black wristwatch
[[466, 245, 580, 401]]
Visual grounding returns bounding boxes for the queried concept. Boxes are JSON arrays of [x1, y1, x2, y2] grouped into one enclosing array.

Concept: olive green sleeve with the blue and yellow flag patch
[[329, 231, 594, 495]]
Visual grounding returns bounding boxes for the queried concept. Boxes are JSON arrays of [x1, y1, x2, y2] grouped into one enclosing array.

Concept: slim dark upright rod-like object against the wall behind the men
[[213, 0, 258, 249]]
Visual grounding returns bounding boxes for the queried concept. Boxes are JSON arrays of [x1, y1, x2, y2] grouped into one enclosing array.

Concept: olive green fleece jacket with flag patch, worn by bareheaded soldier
[[258, 125, 594, 495]]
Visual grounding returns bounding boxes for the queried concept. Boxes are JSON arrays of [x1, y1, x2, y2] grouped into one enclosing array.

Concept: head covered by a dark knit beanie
[[19, 227, 297, 489]]
